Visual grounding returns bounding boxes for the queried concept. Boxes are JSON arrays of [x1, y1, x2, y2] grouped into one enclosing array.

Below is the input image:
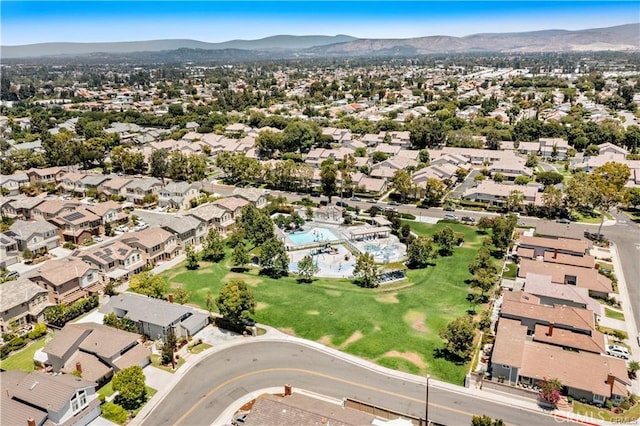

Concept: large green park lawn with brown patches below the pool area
[[163, 222, 484, 384]]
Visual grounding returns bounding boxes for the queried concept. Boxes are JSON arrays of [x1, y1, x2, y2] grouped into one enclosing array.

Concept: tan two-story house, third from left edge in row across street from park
[[74, 241, 147, 281]]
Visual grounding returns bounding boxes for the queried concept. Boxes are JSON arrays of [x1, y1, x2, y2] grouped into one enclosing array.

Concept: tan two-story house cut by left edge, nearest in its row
[[0, 278, 51, 333]]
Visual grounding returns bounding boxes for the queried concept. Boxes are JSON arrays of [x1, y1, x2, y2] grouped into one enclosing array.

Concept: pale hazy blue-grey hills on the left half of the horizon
[[1, 34, 356, 58]]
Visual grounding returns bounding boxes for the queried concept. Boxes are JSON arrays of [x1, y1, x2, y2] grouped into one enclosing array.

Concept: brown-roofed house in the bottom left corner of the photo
[[0, 370, 100, 426]]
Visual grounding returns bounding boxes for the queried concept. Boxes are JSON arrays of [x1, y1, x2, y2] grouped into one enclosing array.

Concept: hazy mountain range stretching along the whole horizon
[[1, 23, 640, 60]]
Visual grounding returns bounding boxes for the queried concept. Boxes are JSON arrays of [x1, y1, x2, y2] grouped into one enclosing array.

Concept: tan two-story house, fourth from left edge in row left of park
[[121, 227, 180, 265]]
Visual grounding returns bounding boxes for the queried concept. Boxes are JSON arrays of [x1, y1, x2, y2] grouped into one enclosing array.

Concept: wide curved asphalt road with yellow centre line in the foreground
[[143, 341, 558, 426]]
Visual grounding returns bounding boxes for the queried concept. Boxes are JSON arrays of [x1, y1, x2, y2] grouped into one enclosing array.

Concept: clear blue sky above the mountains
[[0, 0, 640, 45]]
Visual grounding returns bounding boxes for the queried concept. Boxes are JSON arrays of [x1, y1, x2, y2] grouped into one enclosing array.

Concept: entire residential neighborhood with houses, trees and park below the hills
[[0, 15, 640, 426]]
